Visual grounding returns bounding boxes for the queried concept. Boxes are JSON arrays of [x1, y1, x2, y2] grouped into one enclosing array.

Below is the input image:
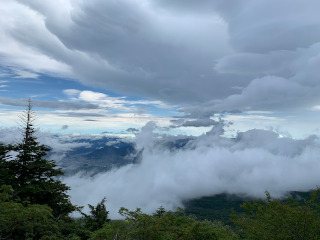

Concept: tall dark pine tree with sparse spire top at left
[[7, 100, 75, 218]]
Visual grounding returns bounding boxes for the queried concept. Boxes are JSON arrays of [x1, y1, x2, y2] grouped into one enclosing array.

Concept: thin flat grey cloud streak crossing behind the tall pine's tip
[[0, 97, 99, 110]]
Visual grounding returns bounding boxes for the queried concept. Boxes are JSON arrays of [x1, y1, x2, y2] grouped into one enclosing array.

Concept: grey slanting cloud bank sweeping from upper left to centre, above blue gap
[[3, 0, 230, 103]]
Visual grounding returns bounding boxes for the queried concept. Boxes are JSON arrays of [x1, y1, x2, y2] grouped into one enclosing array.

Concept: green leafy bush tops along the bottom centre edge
[[90, 207, 237, 240]]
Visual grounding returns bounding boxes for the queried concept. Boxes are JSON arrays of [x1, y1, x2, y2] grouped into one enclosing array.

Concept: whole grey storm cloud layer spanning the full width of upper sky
[[2, 0, 320, 115]]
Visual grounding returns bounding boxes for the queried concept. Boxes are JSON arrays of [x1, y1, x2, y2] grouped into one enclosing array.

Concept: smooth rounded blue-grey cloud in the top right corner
[[215, 0, 320, 52]]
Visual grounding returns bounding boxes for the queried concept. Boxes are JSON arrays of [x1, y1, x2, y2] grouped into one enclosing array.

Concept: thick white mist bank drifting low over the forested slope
[[63, 123, 320, 218]]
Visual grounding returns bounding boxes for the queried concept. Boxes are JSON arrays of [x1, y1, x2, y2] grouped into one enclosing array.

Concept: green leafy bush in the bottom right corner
[[233, 190, 320, 240]]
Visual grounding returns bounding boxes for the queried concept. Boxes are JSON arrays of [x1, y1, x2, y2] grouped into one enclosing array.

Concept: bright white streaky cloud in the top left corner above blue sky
[[0, 0, 71, 76]]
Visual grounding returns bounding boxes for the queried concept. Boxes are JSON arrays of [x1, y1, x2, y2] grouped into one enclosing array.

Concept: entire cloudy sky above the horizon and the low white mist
[[0, 0, 320, 137]]
